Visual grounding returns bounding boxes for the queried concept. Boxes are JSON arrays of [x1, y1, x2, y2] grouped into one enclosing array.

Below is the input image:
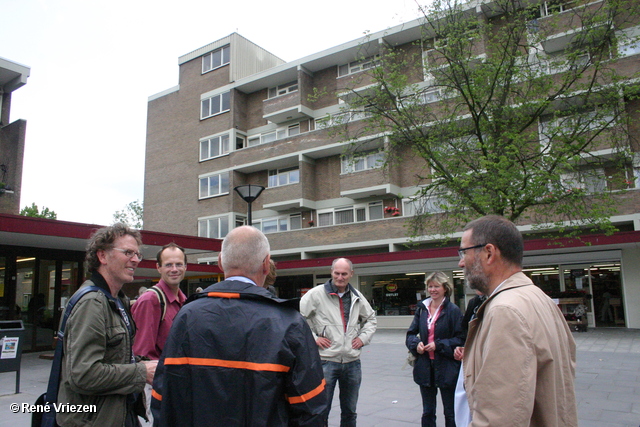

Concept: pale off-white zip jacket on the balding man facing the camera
[[300, 280, 377, 363]]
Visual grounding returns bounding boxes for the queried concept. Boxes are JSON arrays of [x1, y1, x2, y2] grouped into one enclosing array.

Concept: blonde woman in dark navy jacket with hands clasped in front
[[406, 271, 464, 427]]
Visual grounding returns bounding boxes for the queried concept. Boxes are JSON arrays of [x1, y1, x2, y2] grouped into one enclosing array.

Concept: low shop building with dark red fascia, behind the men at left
[[0, 214, 221, 352]]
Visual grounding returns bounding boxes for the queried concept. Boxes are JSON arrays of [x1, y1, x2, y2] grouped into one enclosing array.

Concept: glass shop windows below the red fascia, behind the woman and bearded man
[[356, 251, 627, 327]]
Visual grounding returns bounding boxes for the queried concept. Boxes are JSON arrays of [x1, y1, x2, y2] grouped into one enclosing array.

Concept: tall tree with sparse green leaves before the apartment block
[[330, 0, 640, 236]]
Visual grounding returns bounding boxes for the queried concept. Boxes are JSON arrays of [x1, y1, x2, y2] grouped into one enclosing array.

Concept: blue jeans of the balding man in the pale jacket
[[322, 360, 362, 427]]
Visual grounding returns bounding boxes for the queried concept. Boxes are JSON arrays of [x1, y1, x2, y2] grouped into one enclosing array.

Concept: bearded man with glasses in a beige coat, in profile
[[458, 215, 578, 427]]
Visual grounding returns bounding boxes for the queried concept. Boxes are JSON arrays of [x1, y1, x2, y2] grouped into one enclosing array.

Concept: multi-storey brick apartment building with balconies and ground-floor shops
[[144, 1, 640, 328]]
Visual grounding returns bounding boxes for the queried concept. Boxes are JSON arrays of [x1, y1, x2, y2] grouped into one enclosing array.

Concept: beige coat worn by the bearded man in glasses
[[463, 272, 578, 427]]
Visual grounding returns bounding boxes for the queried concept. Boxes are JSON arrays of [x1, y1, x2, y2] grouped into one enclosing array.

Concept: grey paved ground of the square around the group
[[0, 329, 640, 427]]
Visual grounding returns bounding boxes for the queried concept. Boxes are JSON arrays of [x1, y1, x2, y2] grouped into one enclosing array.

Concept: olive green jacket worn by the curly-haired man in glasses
[[56, 273, 146, 427]]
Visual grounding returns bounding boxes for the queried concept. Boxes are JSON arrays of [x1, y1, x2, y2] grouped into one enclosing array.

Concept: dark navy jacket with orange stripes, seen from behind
[[151, 280, 326, 427]]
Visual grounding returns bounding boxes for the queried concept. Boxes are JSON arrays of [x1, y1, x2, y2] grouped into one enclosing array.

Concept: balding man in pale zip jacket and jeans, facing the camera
[[300, 258, 377, 427]]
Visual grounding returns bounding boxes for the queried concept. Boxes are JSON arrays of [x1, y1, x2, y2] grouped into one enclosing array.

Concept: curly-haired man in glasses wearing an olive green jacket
[[56, 224, 158, 427]]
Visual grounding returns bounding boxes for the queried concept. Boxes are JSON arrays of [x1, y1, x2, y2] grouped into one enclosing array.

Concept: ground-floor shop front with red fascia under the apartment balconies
[[275, 236, 640, 330]]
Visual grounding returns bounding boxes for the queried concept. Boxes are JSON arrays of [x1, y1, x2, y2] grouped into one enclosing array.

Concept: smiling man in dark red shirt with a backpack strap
[[131, 243, 187, 424]]
